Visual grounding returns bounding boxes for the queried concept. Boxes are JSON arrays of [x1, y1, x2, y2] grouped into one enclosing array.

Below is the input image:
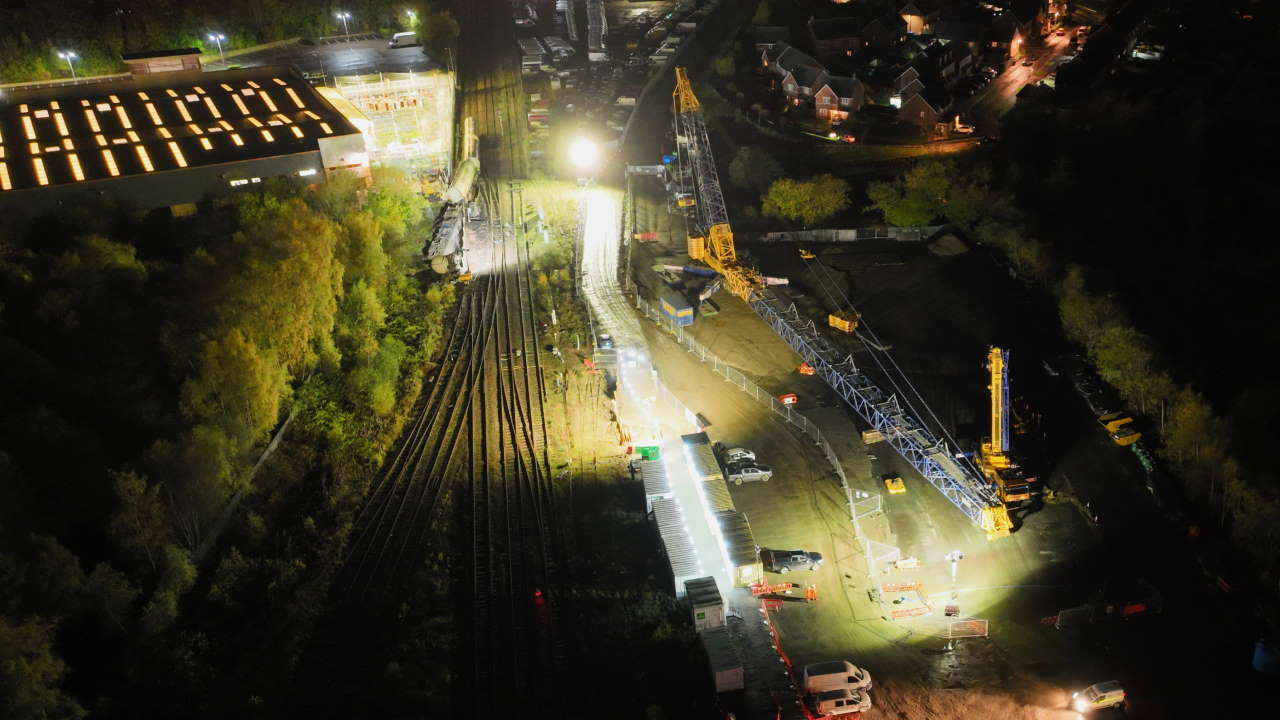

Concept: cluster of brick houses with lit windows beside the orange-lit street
[[755, 0, 1048, 129]]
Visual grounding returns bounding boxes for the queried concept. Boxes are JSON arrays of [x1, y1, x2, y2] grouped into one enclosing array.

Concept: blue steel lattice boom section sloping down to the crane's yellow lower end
[[750, 291, 1002, 529]]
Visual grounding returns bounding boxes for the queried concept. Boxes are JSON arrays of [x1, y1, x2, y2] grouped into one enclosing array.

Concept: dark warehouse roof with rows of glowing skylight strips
[[0, 65, 357, 192]]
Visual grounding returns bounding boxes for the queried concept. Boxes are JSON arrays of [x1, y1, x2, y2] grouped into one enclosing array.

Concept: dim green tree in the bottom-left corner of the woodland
[[0, 616, 86, 720]]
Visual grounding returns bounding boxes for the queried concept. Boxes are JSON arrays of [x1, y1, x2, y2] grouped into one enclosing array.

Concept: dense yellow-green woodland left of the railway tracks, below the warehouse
[[0, 165, 452, 719]]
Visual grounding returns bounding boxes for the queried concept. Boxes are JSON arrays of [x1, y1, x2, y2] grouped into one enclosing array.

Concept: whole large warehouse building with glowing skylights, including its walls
[[0, 51, 369, 211]]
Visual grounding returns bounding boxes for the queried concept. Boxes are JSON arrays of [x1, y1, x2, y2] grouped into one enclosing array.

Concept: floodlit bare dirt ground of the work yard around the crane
[[619, 181, 1131, 717]]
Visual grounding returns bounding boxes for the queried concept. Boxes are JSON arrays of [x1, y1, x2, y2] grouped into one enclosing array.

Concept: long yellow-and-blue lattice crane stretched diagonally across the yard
[[668, 67, 1012, 539]]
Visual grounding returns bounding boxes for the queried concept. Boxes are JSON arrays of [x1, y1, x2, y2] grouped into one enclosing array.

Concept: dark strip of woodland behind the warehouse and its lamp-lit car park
[[0, 0, 458, 83]]
